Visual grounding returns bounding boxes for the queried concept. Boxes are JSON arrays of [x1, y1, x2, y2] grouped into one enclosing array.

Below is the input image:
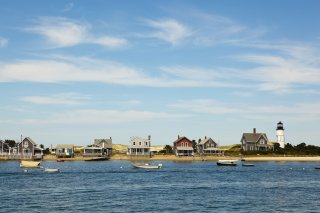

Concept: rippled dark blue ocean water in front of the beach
[[0, 161, 320, 212]]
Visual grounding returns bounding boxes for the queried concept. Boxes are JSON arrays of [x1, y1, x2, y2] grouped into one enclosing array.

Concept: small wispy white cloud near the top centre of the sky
[[144, 19, 192, 46]]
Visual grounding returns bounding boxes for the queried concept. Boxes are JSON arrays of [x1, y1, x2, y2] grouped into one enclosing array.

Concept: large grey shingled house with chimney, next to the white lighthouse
[[240, 128, 272, 151]]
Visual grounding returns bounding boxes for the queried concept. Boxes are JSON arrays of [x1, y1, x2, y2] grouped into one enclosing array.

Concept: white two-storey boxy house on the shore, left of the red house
[[127, 135, 151, 156]]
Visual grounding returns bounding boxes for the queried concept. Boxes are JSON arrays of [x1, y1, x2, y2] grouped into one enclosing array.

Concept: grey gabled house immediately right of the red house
[[198, 136, 225, 155]]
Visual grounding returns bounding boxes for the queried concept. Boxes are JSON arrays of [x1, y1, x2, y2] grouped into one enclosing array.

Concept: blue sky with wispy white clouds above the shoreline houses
[[0, 0, 320, 147]]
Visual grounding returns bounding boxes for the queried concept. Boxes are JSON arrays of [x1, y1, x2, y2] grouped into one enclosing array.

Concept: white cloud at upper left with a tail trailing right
[[25, 17, 127, 48]]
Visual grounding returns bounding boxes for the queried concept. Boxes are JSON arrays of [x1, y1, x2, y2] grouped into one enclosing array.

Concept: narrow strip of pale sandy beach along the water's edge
[[0, 155, 320, 162]]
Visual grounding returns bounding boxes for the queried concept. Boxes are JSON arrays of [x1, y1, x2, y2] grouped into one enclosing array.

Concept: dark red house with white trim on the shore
[[173, 135, 194, 156]]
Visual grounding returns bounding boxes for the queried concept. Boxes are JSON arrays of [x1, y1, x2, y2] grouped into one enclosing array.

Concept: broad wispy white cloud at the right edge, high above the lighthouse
[[237, 44, 320, 93]]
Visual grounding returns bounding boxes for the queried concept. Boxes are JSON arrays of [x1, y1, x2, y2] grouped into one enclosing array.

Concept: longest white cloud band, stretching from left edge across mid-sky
[[0, 56, 245, 87]]
